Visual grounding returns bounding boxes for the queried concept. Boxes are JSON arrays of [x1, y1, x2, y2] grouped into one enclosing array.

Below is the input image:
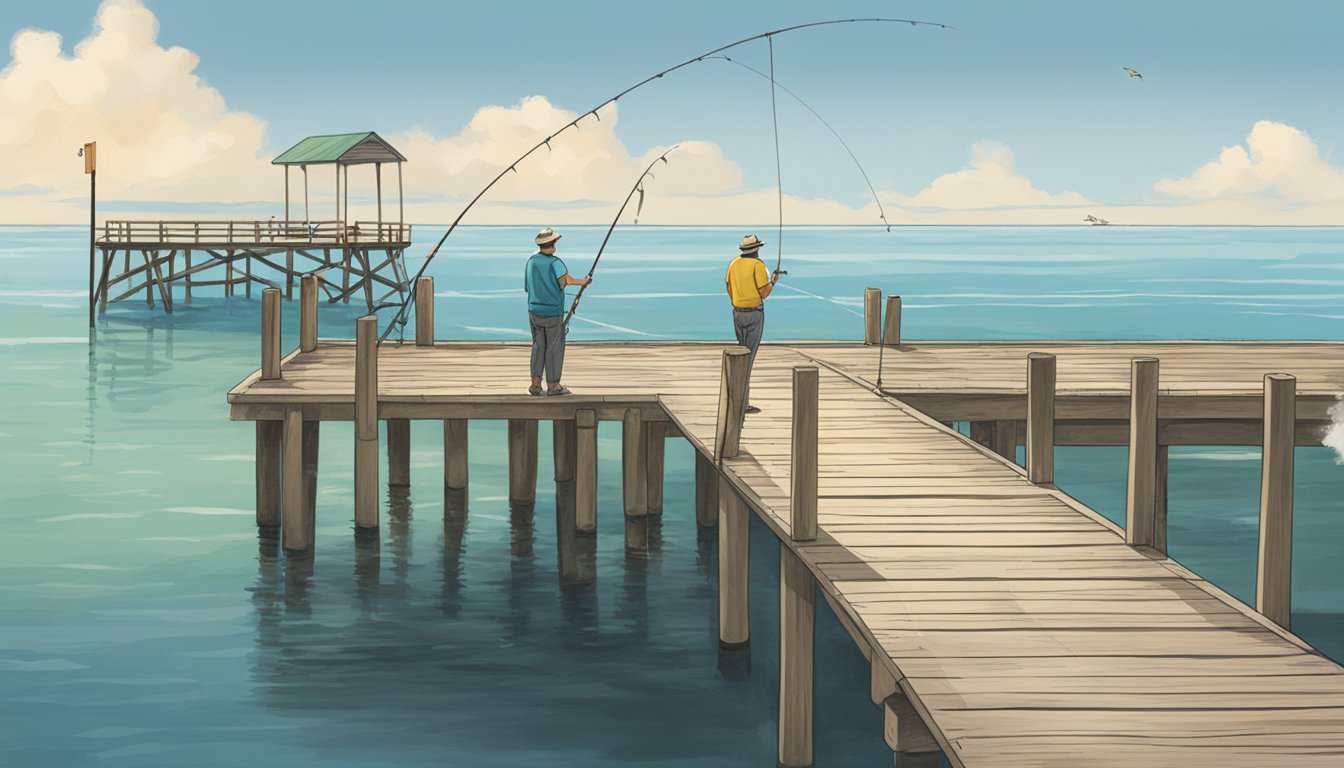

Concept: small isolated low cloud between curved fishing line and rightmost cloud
[[899, 140, 1091, 211]]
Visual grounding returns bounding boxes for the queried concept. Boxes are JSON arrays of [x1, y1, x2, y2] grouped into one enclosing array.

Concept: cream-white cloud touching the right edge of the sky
[[1154, 120, 1344, 203]]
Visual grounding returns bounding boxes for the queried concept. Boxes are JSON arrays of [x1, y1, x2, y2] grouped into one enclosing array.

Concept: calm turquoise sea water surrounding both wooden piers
[[0, 227, 1344, 767]]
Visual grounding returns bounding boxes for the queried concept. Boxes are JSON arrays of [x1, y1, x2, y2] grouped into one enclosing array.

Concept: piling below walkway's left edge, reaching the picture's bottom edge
[[778, 543, 817, 768]]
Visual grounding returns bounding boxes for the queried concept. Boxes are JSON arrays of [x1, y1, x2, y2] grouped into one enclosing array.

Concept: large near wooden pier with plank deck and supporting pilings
[[228, 286, 1344, 768]]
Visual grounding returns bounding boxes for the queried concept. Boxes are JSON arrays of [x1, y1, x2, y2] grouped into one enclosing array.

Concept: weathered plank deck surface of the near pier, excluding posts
[[228, 342, 1344, 768]]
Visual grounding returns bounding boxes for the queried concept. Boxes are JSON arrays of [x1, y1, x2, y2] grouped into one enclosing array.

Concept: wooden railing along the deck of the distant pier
[[99, 219, 411, 245]]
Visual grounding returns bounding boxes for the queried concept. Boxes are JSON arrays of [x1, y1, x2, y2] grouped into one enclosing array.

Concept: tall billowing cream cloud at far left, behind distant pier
[[0, 0, 276, 221]]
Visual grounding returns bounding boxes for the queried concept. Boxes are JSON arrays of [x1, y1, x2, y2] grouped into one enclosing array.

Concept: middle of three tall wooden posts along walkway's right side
[[1125, 358, 1159, 546]]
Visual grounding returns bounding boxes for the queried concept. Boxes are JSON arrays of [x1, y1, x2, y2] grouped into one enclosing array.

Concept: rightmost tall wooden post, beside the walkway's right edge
[[1255, 374, 1297, 629]]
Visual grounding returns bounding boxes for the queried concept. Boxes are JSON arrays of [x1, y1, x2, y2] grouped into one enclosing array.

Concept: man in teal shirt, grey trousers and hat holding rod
[[523, 227, 593, 395]]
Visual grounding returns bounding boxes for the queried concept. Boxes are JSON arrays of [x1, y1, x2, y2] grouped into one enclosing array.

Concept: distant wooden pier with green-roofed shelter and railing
[[89, 132, 411, 313]]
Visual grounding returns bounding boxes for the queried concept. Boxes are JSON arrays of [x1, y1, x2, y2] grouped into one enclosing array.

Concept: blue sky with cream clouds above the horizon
[[0, 0, 1344, 225]]
